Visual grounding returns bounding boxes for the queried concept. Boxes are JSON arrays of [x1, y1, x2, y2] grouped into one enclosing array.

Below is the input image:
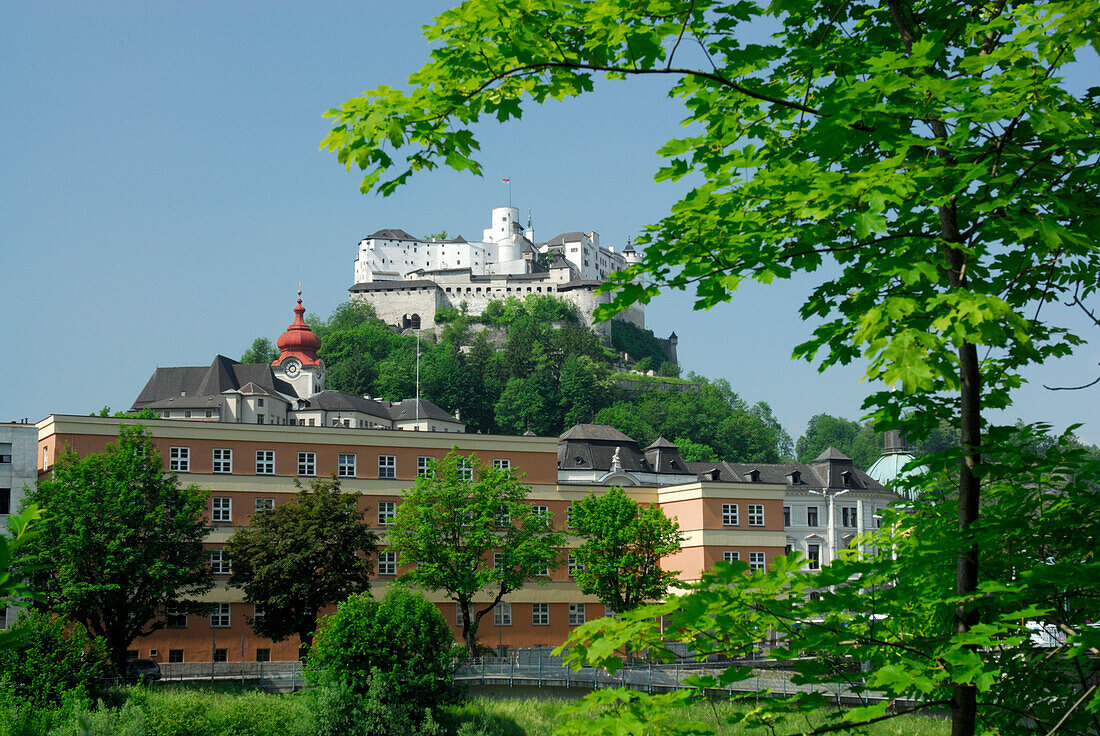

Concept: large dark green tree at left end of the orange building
[[20, 425, 213, 672]]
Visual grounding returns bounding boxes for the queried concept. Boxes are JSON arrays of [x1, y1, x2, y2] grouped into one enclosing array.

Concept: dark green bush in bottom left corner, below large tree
[[0, 611, 113, 707]]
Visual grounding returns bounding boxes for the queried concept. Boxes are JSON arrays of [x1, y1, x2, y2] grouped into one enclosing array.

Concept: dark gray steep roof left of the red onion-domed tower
[[130, 355, 295, 411]]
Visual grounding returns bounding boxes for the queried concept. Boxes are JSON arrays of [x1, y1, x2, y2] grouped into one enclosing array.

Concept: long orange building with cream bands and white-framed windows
[[37, 415, 784, 662]]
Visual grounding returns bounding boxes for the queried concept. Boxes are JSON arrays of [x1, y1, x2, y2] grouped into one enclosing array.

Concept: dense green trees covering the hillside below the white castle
[[249, 295, 794, 462]]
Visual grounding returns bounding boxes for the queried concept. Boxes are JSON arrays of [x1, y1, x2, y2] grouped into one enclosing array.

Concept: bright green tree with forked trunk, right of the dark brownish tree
[[386, 450, 564, 655]]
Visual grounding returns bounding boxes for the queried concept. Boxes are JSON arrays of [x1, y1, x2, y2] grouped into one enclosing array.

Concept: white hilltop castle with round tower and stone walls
[[349, 207, 646, 337]]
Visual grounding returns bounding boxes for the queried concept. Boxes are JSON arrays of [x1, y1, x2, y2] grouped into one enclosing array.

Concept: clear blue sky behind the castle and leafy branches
[[0, 1, 1100, 442]]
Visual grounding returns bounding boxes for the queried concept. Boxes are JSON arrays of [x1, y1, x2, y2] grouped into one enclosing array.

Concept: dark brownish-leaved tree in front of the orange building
[[226, 479, 376, 647]]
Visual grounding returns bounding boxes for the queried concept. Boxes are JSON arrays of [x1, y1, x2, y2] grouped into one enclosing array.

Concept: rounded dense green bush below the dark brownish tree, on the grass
[[306, 587, 455, 708]]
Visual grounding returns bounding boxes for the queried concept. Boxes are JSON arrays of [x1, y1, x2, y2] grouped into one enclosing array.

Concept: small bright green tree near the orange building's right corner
[[570, 486, 684, 614]]
